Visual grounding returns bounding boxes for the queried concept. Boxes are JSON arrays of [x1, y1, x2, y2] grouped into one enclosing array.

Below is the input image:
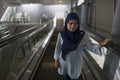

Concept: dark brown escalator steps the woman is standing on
[[33, 31, 83, 80]]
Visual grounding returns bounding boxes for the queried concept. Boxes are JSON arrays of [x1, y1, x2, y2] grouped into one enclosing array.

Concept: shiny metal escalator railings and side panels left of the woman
[[0, 20, 55, 80]]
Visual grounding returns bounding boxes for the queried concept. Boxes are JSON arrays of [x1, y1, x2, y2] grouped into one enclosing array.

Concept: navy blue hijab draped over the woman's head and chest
[[61, 12, 85, 60]]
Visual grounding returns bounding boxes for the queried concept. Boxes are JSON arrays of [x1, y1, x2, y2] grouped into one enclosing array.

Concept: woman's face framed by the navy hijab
[[67, 19, 78, 32]]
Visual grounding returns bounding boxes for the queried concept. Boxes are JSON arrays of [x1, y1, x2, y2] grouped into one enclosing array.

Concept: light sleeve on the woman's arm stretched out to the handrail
[[84, 36, 102, 56]]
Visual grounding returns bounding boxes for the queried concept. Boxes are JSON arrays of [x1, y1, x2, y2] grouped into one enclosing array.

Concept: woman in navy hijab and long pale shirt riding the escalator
[[54, 12, 110, 80]]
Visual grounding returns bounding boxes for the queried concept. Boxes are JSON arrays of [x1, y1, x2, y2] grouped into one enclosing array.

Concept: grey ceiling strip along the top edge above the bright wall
[[9, 0, 70, 5]]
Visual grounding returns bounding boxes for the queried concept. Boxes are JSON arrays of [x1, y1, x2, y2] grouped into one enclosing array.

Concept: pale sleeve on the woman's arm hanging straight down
[[54, 33, 62, 60]]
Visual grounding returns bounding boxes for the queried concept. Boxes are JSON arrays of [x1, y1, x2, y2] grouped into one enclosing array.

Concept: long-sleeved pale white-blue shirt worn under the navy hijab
[[54, 33, 102, 79]]
